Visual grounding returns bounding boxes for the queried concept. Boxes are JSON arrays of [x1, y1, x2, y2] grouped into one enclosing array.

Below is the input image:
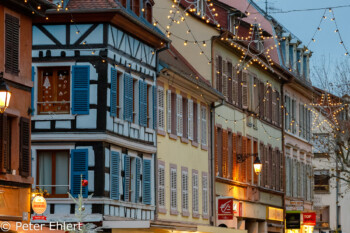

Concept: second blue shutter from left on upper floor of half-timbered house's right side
[[124, 73, 134, 122]]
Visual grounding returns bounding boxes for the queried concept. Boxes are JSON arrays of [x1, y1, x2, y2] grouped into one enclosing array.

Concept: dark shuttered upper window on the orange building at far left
[[5, 14, 19, 75]]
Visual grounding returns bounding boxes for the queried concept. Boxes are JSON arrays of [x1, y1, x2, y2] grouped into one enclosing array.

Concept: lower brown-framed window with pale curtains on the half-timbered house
[[37, 150, 69, 197]]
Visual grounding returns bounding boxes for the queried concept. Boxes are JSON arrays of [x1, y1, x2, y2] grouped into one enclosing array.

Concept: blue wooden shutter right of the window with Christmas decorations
[[72, 66, 90, 115]]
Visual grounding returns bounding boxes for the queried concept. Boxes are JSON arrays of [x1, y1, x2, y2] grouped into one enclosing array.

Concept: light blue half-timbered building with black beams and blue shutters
[[32, 0, 167, 229]]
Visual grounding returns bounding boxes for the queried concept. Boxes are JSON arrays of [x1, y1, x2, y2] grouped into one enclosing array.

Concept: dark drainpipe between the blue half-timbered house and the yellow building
[[154, 43, 170, 224]]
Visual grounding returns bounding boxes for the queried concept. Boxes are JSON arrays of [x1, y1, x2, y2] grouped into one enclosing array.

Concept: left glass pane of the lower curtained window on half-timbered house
[[38, 151, 52, 194]]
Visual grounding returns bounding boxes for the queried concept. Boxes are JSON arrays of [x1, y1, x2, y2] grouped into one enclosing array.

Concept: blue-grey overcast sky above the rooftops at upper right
[[254, 0, 350, 71]]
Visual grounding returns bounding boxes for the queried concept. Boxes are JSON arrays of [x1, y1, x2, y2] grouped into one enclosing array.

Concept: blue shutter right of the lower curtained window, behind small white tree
[[70, 149, 88, 197]]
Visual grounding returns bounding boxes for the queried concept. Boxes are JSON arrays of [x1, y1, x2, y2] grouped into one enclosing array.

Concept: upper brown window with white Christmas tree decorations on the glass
[[37, 67, 71, 114]]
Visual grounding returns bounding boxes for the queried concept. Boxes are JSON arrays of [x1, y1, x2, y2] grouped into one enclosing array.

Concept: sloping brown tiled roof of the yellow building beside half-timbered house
[[159, 46, 224, 99]]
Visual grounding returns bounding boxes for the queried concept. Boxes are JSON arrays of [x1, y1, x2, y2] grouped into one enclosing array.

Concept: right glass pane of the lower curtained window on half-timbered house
[[56, 151, 69, 194]]
